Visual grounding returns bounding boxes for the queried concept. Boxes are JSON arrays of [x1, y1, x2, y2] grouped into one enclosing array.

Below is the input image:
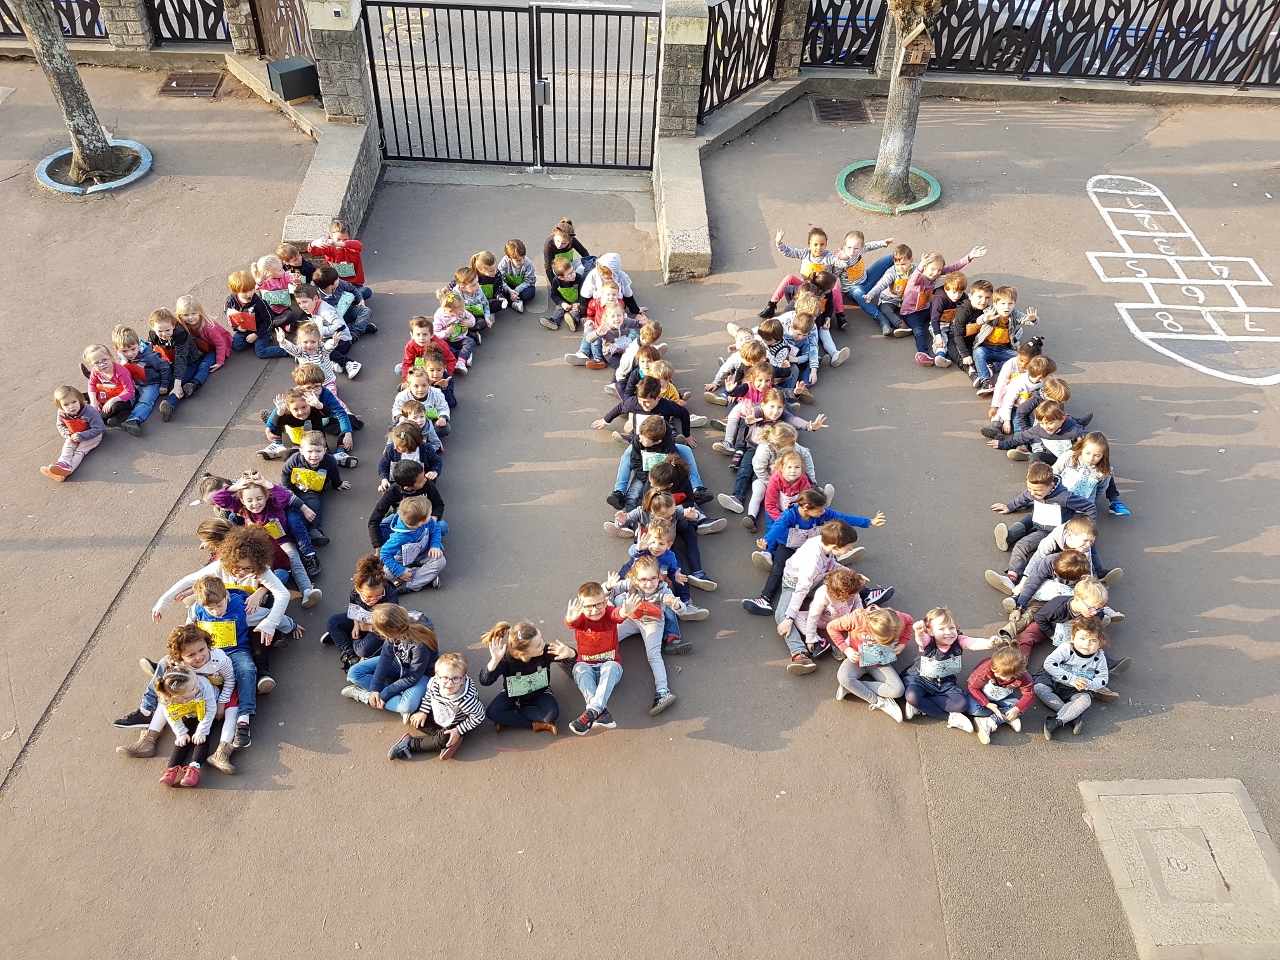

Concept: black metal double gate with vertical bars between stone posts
[[364, 0, 660, 169]]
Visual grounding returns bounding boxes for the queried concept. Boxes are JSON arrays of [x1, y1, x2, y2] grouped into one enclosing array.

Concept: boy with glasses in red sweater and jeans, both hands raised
[[564, 580, 640, 736]]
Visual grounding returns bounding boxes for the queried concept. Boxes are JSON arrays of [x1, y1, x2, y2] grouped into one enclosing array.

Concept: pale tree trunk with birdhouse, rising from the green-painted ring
[[867, 0, 946, 206]]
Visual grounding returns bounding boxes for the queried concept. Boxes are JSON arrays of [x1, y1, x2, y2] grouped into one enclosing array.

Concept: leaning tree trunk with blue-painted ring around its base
[[8, 0, 138, 186]]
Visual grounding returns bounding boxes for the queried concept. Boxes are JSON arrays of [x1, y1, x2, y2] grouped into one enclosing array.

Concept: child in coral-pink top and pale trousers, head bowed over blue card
[[827, 607, 913, 723]]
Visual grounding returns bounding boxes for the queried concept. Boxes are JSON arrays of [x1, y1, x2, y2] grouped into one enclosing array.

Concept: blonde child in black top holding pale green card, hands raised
[[480, 620, 577, 736]]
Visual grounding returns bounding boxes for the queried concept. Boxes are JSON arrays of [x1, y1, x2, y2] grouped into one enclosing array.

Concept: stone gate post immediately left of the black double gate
[[307, 0, 374, 123]]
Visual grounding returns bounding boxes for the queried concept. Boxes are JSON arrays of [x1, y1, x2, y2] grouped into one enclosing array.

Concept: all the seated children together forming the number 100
[[99, 212, 1128, 787]]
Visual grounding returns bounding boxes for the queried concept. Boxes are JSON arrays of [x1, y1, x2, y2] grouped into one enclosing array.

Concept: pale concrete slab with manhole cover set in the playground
[[1080, 780, 1280, 960]]
